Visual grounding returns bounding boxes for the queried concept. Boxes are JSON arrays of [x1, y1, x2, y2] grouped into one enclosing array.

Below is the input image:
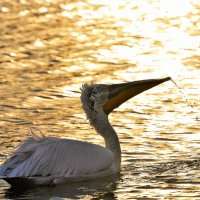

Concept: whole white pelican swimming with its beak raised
[[0, 77, 171, 186]]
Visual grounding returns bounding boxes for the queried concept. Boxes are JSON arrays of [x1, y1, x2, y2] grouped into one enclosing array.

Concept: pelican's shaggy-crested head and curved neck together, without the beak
[[81, 84, 121, 170]]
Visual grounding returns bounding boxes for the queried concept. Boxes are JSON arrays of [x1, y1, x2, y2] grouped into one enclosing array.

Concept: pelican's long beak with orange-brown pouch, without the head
[[103, 77, 171, 115]]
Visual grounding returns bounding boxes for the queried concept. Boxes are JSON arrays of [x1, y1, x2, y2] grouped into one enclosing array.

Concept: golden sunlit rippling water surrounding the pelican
[[0, 0, 200, 199]]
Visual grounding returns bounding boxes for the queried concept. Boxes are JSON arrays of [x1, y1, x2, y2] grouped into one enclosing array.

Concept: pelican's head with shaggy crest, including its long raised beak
[[81, 77, 171, 127]]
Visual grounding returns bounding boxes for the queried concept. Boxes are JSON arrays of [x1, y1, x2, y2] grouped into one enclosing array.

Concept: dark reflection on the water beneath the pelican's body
[[5, 175, 119, 200]]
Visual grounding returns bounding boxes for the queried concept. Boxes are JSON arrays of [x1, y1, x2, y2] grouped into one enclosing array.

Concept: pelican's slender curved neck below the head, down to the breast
[[94, 116, 121, 168]]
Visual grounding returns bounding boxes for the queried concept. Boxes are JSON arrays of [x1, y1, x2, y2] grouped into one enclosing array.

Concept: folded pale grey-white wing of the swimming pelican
[[0, 137, 114, 177]]
